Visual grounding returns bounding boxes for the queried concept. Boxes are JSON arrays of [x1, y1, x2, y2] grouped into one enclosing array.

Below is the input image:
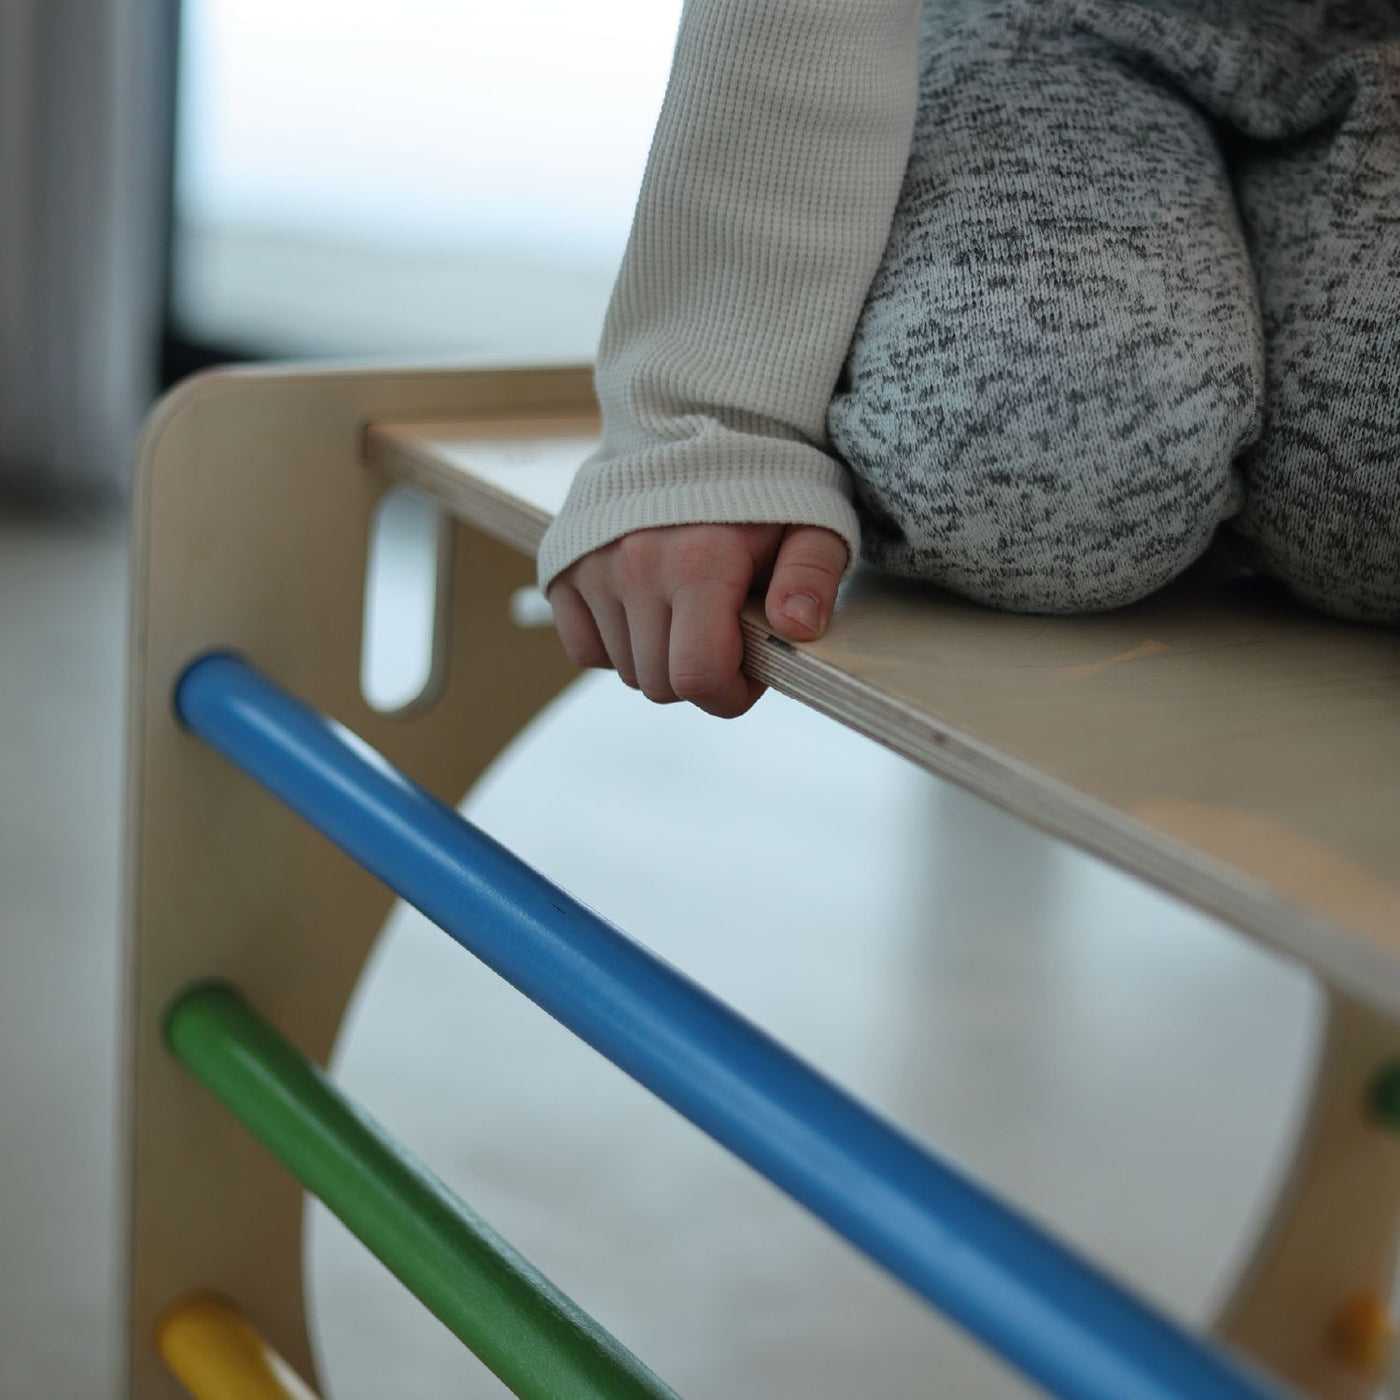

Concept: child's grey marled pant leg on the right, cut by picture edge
[[1231, 4, 1400, 626]]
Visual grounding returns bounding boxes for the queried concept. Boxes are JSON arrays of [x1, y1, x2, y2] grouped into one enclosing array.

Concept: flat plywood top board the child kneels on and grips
[[370, 417, 1400, 1014]]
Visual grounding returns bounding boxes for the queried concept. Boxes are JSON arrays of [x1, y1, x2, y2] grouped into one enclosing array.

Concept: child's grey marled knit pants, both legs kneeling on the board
[[827, 0, 1400, 624]]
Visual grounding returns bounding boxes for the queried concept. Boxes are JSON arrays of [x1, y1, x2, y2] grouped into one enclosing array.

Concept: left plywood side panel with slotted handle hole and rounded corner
[[123, 367, 595, 1400]]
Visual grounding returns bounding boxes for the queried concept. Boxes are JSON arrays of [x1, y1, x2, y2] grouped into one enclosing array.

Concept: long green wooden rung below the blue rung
[[167, 984, 676, 1400]]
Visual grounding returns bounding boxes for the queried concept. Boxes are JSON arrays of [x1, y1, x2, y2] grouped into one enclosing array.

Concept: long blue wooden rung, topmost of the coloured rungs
[[175, 654, 1285, 1400]]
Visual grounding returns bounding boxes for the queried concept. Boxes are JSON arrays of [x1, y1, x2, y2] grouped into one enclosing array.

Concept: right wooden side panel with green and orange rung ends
[[1215, 990, 1400, 1400]]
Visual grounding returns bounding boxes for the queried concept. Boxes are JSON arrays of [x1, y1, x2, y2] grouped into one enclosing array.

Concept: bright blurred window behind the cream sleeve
[[171, 0, 680, 361]]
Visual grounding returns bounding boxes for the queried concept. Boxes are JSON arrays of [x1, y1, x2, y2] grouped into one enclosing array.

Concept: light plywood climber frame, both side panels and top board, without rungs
[[126, 367, 1400, 1400]]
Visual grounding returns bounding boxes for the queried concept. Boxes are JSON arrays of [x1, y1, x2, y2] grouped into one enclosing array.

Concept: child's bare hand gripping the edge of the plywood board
[[549, 525, 847, 720]]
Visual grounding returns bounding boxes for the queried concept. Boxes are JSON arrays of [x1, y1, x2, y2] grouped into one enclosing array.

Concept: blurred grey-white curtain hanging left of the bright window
[[0, 0, 172, 496]]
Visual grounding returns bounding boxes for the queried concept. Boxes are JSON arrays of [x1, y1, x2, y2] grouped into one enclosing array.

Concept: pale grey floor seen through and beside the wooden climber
[[0, 519, 1315, 1400]]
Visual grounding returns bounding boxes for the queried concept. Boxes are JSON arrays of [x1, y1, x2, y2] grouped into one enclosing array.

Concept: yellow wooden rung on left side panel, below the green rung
[[157, 1296, 316, 1400]]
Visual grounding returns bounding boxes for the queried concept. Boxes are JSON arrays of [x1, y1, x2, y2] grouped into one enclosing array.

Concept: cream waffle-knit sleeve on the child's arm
[[539, 0, 920, 588]]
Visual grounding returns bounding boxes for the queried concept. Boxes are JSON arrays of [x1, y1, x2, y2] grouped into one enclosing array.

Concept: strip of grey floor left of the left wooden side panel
[[0, 518, 126, 1400]]
